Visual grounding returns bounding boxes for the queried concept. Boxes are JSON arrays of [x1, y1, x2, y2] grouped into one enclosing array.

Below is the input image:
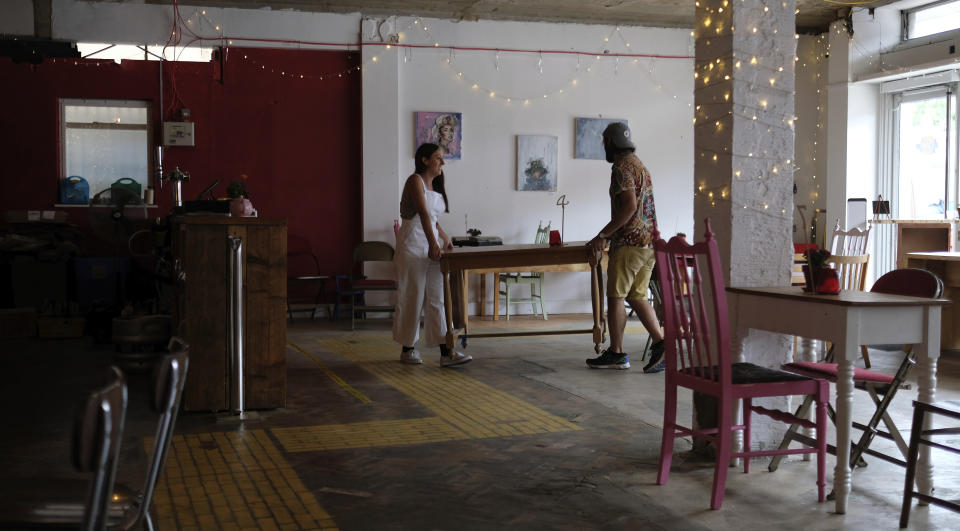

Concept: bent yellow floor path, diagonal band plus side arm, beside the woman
[[273, 334, 582, 452]]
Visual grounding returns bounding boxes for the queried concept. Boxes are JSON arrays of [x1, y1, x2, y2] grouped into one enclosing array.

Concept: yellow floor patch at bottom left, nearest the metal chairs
[[152, 430, 337, 529]]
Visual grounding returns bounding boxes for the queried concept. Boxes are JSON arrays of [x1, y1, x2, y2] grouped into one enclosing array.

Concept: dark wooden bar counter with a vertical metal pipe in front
[[172, 216, 287, 411]]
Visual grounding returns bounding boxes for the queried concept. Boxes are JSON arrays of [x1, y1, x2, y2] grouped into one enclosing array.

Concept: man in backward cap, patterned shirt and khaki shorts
[[587, 122, 664, 373]]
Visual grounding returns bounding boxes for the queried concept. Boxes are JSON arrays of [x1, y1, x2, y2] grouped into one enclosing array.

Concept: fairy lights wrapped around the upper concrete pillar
[[693, 0, 799, 218]]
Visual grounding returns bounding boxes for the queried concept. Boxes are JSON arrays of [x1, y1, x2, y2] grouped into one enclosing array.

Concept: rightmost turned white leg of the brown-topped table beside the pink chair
[[915, 306, 941, 505]]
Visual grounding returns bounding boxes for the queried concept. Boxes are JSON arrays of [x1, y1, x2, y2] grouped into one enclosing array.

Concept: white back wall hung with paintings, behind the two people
[[364, 17, 693, 313]]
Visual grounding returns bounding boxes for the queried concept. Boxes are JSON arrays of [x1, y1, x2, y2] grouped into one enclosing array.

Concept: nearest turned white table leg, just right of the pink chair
[[833, 336, 860, 514]]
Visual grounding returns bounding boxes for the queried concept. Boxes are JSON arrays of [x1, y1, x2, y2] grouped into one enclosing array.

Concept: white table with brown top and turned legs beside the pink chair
[[727, 286, 949, 514]]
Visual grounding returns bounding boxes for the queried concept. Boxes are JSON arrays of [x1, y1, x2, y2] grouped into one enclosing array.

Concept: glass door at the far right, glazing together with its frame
[[892, 85, 957, 219]]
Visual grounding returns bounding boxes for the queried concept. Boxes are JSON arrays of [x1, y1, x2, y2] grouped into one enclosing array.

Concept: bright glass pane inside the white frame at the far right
[[898, 96, 956, 219]]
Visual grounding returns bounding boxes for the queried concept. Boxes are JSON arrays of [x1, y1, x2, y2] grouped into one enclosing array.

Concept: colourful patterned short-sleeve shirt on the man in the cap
[[610, 153, 657, 249]]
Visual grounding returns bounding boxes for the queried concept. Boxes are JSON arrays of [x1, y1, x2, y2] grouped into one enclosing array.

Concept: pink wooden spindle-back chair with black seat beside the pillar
[[653, 220, 829, 509]]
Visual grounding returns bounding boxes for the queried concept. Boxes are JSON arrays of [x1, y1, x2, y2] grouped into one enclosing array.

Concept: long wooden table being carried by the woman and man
[[440, 242, 606, 352]]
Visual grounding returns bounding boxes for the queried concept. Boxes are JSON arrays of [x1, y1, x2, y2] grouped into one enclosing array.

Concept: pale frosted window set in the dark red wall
[[60, 99, 152, 202]]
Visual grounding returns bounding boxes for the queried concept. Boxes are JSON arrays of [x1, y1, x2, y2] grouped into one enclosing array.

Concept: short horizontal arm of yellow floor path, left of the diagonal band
[[271, 417, 470, 452]]
